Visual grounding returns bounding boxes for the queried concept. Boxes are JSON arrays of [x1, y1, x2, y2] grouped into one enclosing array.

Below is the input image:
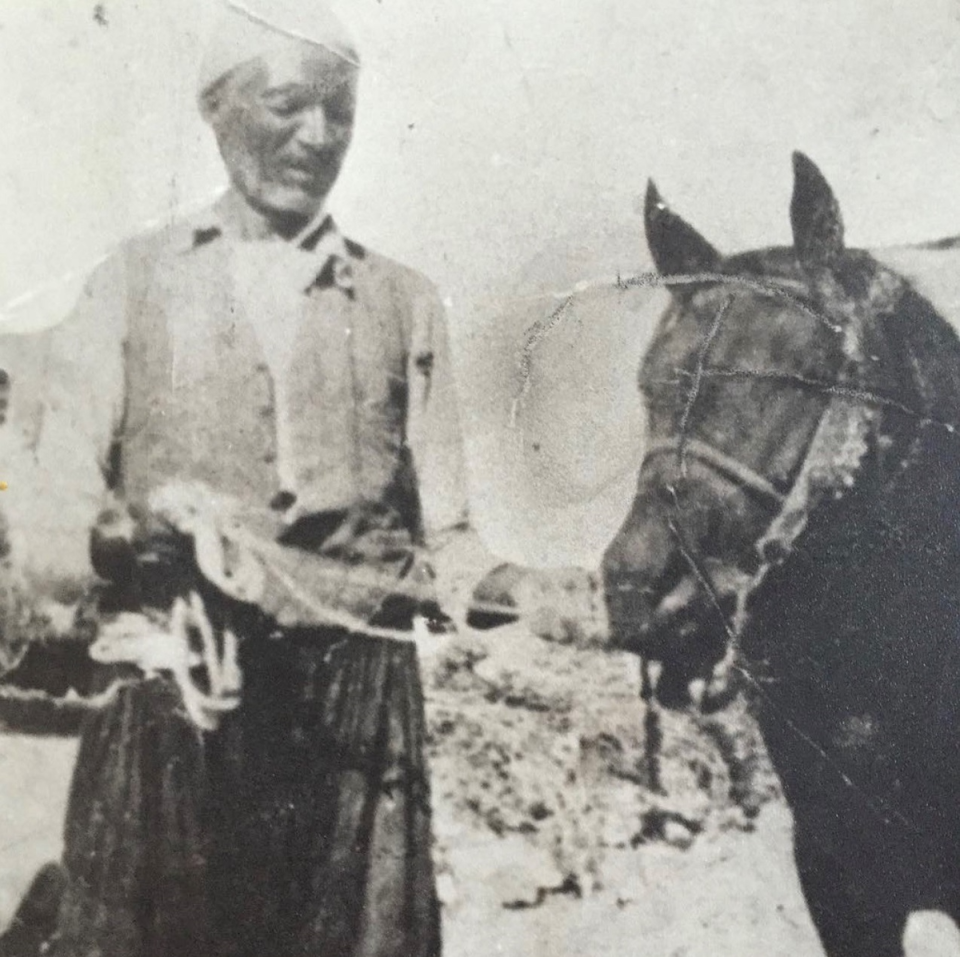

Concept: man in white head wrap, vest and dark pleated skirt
[[0, 0, 496, 957]]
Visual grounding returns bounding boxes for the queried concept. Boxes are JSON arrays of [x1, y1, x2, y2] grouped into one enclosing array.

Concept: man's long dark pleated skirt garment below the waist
[[42, 630, 440, 957]]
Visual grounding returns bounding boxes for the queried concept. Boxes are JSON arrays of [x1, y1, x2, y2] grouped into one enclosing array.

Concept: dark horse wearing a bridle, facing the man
[[603, 153, 960, 957]]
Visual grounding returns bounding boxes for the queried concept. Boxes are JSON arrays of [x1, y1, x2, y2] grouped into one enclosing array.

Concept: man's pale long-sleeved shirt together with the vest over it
[[0, 196, 483, 620]]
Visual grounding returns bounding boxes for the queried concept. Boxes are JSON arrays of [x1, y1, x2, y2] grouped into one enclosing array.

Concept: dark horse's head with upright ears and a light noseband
[[603, 154, 924, 706]]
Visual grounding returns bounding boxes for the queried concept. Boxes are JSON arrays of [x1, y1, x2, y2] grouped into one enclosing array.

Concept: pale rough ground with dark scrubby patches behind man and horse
[[0, 625, 957, 957]]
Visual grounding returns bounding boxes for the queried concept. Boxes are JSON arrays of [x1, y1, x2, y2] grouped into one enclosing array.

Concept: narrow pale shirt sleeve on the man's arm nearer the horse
[[407, 280, 497, 624]]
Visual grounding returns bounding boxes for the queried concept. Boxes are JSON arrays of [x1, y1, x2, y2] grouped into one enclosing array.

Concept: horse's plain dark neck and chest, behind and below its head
[[742, 270, 960, 955]]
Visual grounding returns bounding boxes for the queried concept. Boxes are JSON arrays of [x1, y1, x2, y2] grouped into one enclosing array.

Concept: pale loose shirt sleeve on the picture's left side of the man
[[0, 256, 127, 594]]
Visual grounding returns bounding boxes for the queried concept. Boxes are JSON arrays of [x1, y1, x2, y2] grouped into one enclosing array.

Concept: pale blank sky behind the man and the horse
[[0, 0, 960, 562]]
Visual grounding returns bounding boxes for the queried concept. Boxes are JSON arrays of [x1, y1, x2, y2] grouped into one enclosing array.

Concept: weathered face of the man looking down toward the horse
[[209, 42, 357, 231]]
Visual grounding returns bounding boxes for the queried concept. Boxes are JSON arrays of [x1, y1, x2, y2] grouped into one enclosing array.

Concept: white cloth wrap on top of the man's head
[[200, 0, 360, 93]]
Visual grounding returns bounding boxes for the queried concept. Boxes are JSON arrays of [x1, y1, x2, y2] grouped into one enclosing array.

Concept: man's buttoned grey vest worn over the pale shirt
[[114, 222, 423, 534]]
